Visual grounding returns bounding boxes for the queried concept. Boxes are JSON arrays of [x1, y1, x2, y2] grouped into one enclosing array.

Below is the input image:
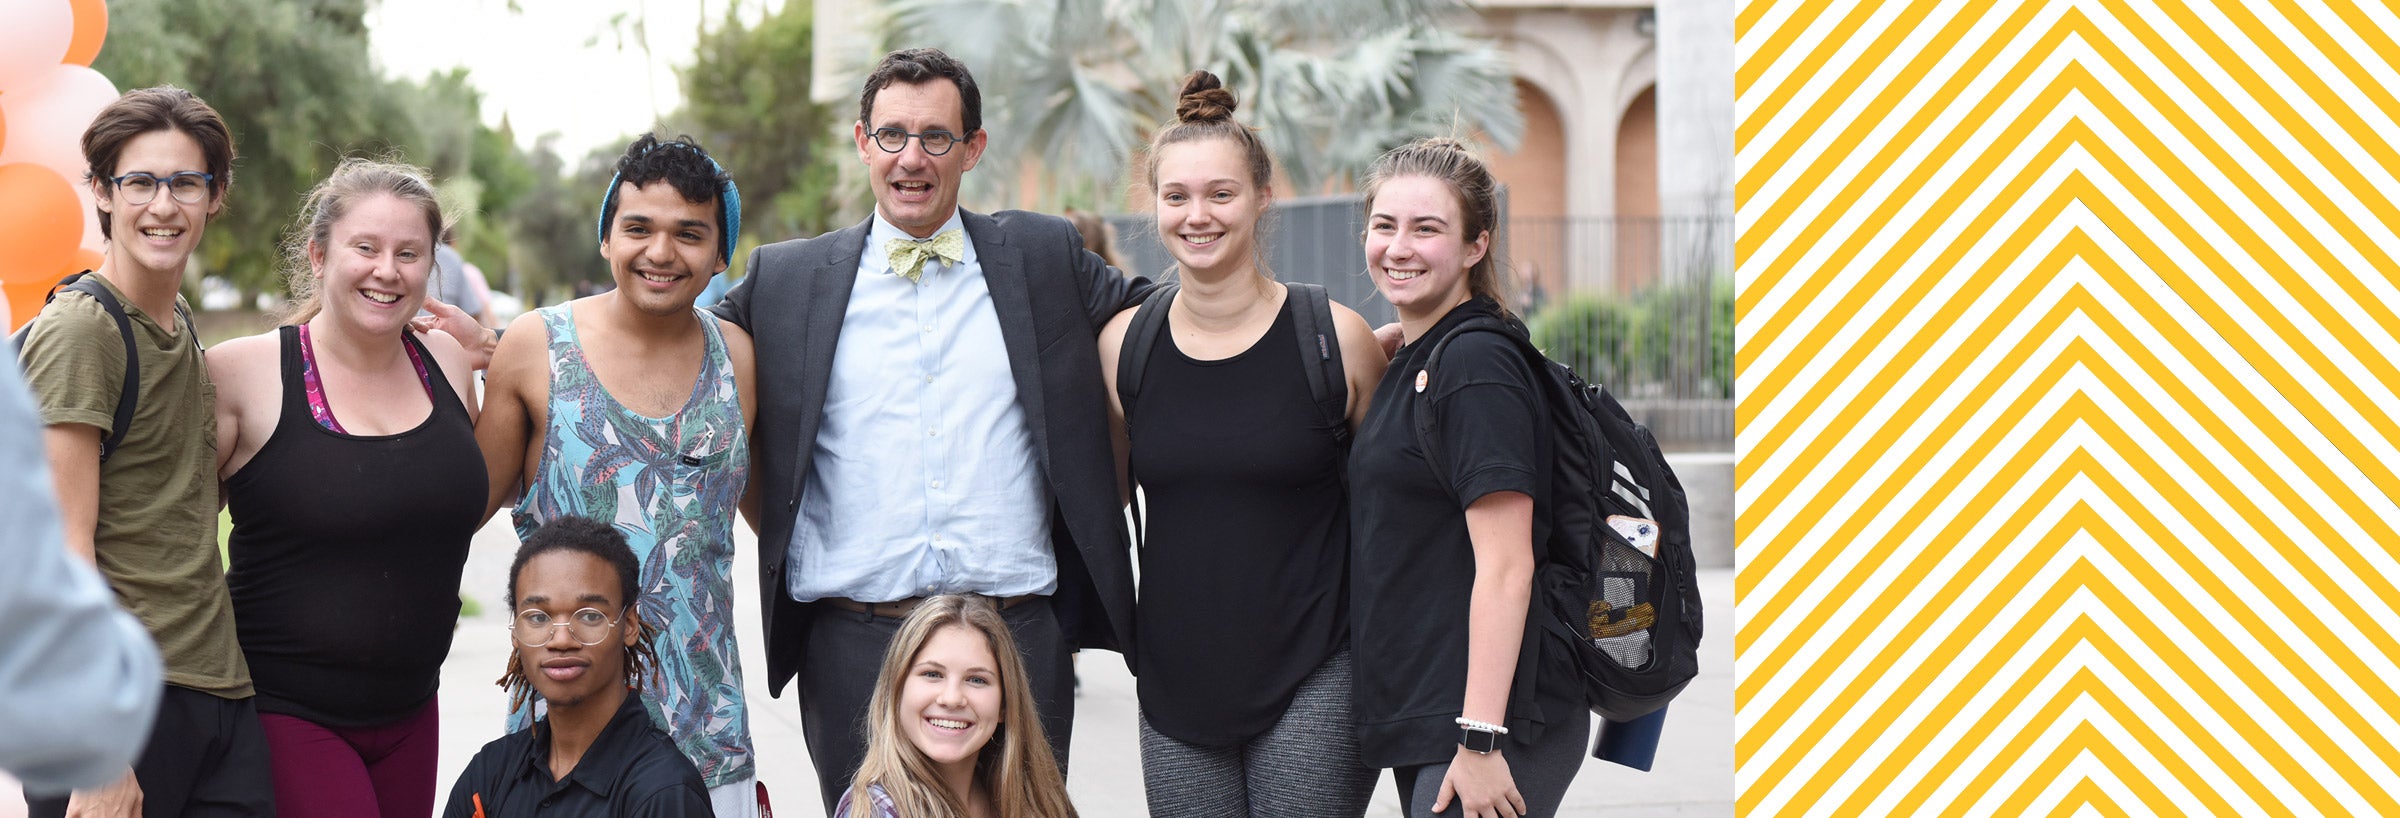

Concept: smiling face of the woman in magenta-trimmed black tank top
[[310, 194, 434, 333]]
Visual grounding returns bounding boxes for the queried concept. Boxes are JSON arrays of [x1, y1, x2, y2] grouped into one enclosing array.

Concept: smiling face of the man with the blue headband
[[600, 180, 725, 314]]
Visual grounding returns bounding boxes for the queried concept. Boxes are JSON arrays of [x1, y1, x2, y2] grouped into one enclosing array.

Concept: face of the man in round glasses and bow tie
[[852, 79, 984, 237]]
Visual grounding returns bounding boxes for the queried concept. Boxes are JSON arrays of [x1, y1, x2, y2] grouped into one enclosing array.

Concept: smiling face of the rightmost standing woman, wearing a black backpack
[[1366, 175, 1490, 324]]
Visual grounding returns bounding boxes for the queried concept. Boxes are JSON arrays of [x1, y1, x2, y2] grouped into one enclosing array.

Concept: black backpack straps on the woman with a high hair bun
[[1116, 283, 1351, 542]]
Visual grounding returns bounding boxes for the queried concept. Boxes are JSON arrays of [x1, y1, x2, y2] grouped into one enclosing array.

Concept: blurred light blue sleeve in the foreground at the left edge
[[0, 362, 166, 796]]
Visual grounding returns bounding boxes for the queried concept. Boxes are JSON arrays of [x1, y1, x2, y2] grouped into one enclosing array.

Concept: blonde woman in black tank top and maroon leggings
[[206, 158, 485, 816]]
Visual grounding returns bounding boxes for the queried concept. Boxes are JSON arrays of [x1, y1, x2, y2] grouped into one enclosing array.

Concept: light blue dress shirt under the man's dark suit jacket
[[787, 213, 1058, 602]]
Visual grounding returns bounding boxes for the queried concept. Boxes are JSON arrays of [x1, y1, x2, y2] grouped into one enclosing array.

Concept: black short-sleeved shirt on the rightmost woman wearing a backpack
[[1349, 297, 1582, 768]]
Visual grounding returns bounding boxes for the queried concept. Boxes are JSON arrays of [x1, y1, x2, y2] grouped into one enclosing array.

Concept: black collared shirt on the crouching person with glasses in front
[[442, 693, 713, 818]]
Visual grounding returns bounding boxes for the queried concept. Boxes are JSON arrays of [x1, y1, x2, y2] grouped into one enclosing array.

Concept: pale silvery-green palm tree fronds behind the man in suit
[[883, 0, 1524, 204]]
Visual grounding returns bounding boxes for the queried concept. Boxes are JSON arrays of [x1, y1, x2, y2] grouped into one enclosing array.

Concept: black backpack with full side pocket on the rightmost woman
[[1416, 317, 1699, 722]]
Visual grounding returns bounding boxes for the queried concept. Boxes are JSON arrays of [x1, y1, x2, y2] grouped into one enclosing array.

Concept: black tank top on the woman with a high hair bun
[[1133, 300, 1349, 746]]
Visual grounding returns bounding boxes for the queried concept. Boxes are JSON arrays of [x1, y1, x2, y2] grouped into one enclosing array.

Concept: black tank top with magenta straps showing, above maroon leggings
[[226, 326, 485, 727]]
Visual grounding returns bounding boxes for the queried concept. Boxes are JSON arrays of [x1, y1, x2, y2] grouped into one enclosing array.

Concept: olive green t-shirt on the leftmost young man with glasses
[[17, 278, 250, 698]]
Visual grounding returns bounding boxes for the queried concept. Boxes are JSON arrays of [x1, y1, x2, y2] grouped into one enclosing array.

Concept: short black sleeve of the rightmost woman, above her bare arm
[[1430, 333, 1548, 509]]
